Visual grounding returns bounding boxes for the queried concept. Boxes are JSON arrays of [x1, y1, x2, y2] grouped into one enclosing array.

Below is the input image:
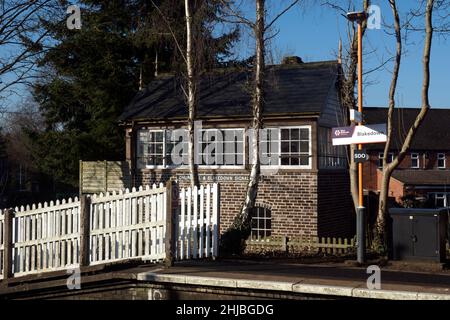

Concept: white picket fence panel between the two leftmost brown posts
[[12, 198, 80, 276]]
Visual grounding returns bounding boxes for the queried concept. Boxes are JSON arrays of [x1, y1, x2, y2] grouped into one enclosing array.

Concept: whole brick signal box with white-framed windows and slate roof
[[120, 58, 354, 238]]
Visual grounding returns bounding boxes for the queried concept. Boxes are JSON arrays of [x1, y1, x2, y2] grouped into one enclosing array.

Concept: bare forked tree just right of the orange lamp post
[[374, 0, 435, 249]]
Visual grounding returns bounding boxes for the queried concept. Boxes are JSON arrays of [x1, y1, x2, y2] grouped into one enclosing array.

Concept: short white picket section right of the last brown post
[[176, 183, 219, 260]]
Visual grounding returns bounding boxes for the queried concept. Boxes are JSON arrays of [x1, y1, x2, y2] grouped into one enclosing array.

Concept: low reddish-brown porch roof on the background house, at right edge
[[392, 169, 450, 186]]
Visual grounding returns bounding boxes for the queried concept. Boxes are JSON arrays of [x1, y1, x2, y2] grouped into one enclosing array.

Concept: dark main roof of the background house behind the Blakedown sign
[[363, 107, 450, 151]]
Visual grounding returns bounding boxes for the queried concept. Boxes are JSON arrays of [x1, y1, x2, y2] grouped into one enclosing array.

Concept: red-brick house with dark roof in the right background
[[363, 108, 450, 207]]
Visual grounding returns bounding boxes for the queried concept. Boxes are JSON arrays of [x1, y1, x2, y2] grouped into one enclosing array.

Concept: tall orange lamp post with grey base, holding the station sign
[[347, 11, 367, 263]]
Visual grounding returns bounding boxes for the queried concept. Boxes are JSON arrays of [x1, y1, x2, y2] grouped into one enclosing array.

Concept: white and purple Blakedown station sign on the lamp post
[[331, 123, 387, 146]]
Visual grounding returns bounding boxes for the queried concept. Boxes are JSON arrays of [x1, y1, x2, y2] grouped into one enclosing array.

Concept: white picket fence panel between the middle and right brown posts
[[90, 184, 167, 264]]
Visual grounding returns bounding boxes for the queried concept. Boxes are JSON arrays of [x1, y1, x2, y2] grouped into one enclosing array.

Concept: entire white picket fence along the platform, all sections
[[0, 184, 219, 279]]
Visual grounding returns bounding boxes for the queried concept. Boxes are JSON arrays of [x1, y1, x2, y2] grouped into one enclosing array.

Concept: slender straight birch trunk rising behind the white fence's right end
[[184, 0, 199, 188]]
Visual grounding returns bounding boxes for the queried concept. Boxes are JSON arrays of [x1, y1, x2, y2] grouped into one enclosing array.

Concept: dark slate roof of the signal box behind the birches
[[119, 61, 339, 121]]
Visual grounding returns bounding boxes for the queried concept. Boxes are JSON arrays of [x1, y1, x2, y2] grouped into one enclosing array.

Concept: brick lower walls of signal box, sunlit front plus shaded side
[[136, 170, 354, 237]]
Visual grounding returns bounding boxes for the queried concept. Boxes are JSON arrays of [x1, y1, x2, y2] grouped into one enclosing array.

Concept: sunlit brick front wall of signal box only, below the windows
[[135, 170, 318, 236]]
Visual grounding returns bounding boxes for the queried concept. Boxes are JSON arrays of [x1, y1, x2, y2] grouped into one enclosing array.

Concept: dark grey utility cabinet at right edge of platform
[[389, 208, 448, 262]]
